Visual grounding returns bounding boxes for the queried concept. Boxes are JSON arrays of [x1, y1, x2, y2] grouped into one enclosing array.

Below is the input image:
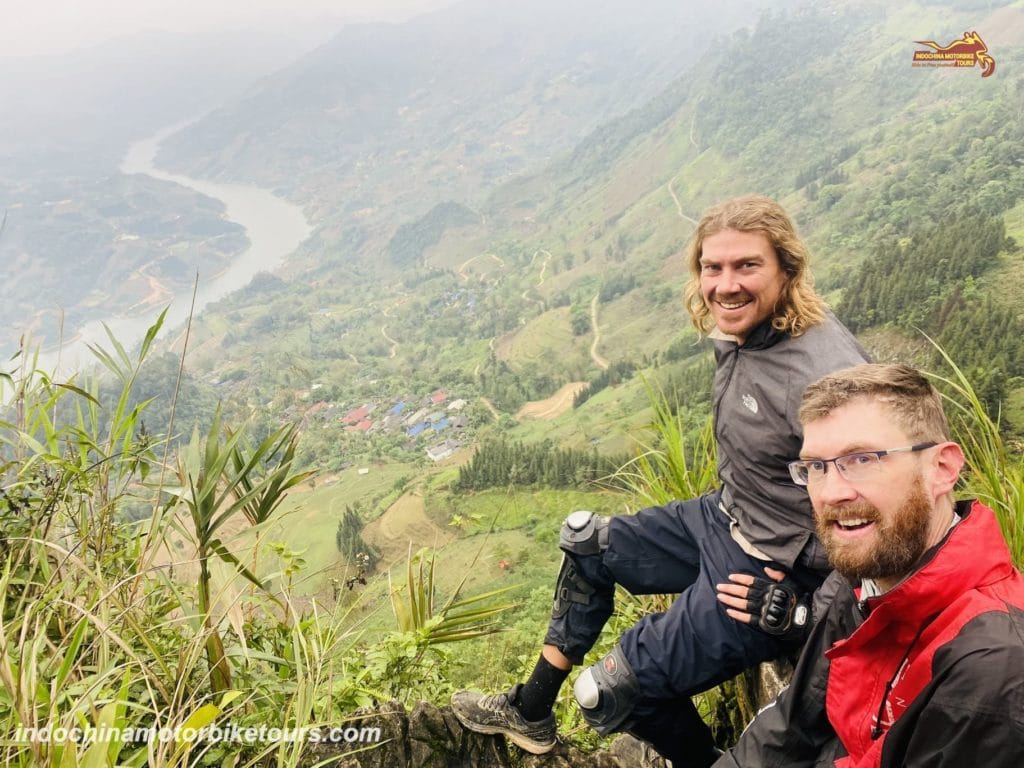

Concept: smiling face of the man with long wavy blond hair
[[700, 229, 786, 344]]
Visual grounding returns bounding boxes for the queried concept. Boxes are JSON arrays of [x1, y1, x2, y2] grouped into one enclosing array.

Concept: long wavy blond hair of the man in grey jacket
[[684, 195, 825, 336]]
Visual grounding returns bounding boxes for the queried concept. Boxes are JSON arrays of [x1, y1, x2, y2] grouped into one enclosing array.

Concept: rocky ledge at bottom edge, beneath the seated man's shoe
[[300, 701, 666, 768]]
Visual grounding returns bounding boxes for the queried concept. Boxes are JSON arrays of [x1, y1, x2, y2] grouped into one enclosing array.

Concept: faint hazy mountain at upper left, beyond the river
[[0, 23, 344, 160]]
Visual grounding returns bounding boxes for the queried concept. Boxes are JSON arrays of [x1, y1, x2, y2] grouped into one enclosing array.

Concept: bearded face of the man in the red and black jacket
[[800, 397, 958, 590]]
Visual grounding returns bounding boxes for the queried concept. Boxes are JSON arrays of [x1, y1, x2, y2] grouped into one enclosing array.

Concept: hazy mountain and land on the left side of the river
[[0, 23, 358, 356]]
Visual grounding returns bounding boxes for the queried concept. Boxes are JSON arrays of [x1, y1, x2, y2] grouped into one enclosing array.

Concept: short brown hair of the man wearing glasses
[[800, 364, 950, 442]]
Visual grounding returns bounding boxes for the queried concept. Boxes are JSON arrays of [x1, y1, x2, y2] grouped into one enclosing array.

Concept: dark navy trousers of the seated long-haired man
[[545, 492, 821, 768]]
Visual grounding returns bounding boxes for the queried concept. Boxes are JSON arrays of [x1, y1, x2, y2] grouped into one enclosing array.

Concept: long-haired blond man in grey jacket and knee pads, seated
[[452, 197, 865, 768]]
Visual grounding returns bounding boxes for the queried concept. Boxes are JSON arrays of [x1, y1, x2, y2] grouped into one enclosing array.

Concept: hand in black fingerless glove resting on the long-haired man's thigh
[[716, 567, 811, 638]]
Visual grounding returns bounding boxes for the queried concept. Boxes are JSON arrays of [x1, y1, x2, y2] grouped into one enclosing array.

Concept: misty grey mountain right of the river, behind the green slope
[[158, 0, 762, 226]]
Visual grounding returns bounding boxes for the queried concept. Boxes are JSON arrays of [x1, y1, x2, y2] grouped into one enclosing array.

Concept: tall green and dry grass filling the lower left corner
[[0, 318, 520, 768]]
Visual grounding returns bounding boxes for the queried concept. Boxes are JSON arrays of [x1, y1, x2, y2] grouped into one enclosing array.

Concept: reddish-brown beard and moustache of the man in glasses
[[815, 475, 932, 582]]
